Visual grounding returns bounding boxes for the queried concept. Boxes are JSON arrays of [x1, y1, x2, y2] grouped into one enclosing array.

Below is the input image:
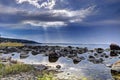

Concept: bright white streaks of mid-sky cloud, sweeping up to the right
[[23, 6, 95, 27]]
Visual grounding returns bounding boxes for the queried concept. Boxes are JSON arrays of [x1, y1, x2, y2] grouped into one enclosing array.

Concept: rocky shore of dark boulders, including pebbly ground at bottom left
[[0, 44, 120, 80]]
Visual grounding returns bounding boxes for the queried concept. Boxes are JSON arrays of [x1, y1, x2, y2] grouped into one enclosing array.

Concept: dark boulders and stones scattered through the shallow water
[[0, 44, 120, 79]]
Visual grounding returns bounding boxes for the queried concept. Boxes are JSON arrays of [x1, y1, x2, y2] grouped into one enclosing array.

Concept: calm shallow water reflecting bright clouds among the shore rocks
[[2, 45, 119, 80]]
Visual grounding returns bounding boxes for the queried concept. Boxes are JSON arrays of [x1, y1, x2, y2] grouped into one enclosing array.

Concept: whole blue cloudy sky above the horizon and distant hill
[[0, 0, 120, 44]]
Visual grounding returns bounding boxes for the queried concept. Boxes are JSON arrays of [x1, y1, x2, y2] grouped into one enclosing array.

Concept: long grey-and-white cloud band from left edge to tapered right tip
[[0, 0, 95, 27]]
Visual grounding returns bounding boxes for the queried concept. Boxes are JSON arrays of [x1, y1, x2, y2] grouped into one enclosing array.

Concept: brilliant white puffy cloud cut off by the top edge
[[16, 0, 56, 9]]
